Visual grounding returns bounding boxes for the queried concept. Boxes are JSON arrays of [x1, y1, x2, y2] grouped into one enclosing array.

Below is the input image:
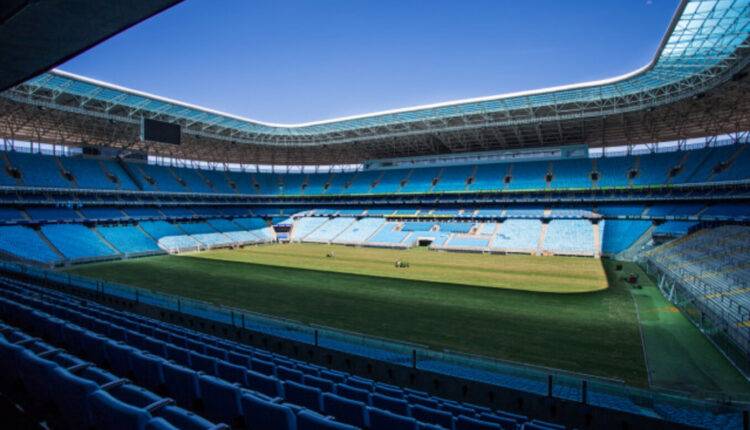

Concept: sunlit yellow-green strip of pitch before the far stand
[[192, 244, 607, 293]]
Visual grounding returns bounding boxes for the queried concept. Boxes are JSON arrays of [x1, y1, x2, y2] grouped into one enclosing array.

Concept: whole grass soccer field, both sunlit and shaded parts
[[71, 244, 646, 385]]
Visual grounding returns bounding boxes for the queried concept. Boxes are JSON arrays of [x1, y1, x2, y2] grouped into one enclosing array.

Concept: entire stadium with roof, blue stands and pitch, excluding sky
[[0, 0, 750, 430]]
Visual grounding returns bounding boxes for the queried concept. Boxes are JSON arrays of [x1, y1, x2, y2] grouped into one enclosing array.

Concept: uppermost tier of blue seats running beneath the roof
[[0, 144, 750, 195]]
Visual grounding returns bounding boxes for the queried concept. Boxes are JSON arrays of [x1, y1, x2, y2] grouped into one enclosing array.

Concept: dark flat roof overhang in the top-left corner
[[0, 0, 182, 90]]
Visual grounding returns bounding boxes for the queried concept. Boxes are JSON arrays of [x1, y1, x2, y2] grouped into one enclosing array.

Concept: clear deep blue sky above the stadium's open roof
[[60, 0, 679, 123]]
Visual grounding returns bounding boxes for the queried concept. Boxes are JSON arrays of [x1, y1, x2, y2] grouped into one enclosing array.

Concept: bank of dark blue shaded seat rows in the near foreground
[[0, 279, 580, 430]]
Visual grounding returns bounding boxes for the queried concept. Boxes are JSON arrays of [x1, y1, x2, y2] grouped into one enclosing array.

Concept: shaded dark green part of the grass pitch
[[71, 250, 646, 385]]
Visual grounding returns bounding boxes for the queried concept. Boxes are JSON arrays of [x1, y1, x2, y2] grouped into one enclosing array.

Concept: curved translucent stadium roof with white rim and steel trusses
[[4, 0, 750, 164]]
